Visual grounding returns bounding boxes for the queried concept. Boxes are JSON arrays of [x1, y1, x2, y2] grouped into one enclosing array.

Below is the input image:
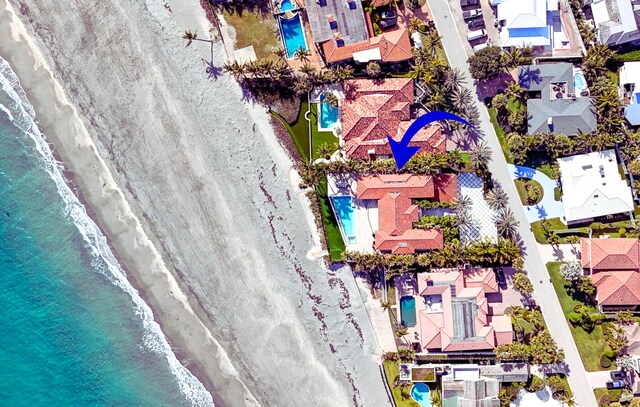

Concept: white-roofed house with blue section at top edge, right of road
[[497, 0, 569, 49]]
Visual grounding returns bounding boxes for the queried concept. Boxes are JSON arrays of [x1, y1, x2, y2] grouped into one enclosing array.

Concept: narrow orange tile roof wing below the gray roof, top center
[[320, 29, 413, 64]]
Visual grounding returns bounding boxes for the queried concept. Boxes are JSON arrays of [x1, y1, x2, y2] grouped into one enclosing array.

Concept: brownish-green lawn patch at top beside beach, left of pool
[[223, 11, 282, 59]]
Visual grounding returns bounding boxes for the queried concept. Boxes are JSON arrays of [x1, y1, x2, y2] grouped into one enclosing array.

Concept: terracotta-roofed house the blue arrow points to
[[356, 174, 458, 254]]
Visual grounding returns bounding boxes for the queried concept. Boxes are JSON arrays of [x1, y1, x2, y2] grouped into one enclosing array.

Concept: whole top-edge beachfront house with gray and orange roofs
[[305, 0, 413, 64]]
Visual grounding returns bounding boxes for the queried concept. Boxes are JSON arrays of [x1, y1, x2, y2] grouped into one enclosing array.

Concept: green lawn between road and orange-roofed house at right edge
[[547, 262, 615, 372]]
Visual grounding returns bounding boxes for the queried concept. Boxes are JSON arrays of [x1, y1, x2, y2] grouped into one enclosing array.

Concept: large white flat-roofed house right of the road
[[558, 150, 633, 224]]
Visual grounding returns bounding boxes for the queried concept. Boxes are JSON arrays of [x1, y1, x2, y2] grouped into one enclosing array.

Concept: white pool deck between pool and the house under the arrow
[[327, 175, 378, 253]]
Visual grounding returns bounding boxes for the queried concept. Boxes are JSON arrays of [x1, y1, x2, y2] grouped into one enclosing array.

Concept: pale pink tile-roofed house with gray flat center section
[[416, 269, 513, 352]]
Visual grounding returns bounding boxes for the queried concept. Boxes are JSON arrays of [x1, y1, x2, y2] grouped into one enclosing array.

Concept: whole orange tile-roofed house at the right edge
[[581, 238, 640, 312]]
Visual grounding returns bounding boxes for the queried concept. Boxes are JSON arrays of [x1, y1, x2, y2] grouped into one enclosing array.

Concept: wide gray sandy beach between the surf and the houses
[[0, 0, 389, 406]]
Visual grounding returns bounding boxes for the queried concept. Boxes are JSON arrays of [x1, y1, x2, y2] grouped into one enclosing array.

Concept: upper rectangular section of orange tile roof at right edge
[[580, 238, 640, 273]]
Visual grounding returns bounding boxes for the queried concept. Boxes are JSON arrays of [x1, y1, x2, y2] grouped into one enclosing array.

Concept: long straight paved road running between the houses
[[428, 0, 598, 407]]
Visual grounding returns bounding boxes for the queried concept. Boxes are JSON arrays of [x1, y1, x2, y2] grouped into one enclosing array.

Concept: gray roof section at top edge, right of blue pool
[[305, 0, 369, 45]]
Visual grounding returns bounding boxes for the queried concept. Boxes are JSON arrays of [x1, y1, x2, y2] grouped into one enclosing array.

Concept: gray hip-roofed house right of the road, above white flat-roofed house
[[518, 63, 597, 135]]
